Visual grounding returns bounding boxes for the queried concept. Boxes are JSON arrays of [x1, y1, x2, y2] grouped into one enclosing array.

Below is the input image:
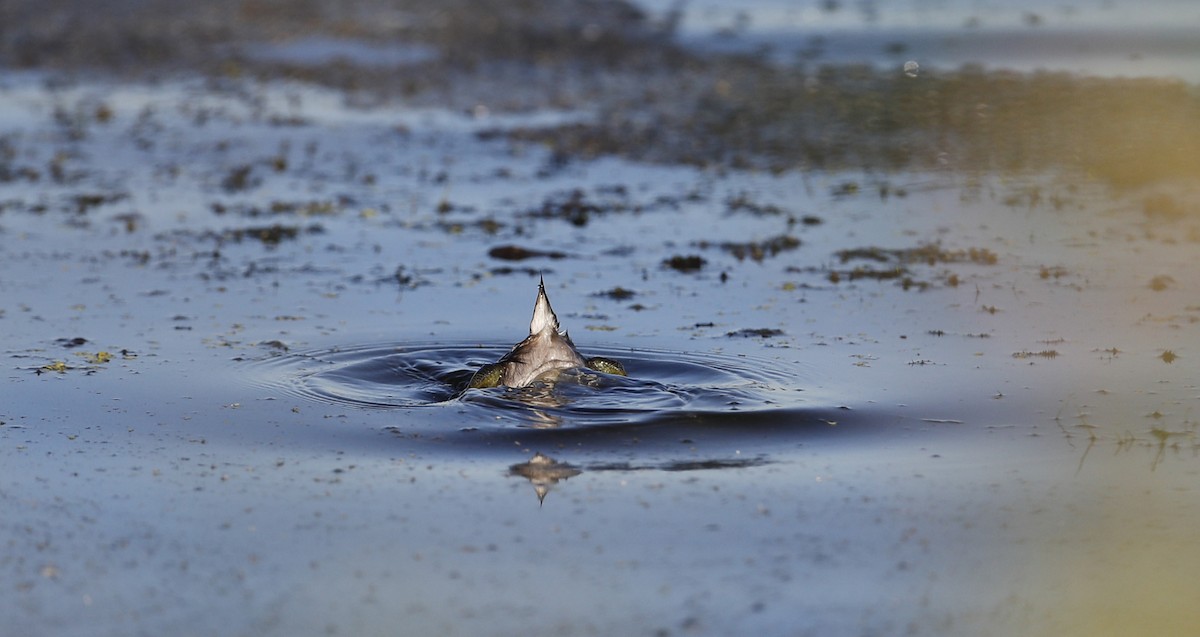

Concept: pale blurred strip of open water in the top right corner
[[640, 0, 1200, 82]]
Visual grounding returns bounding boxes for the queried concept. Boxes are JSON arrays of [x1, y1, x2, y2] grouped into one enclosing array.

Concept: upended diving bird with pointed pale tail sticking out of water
[[468, 280, 628, 387]]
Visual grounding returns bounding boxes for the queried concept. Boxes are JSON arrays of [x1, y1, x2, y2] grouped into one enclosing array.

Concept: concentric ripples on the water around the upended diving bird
[[251, 343, 814, 428]]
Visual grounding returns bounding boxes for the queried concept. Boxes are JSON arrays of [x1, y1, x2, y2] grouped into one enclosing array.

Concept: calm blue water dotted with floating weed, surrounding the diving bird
[[0, 4, 1200, 635]]
